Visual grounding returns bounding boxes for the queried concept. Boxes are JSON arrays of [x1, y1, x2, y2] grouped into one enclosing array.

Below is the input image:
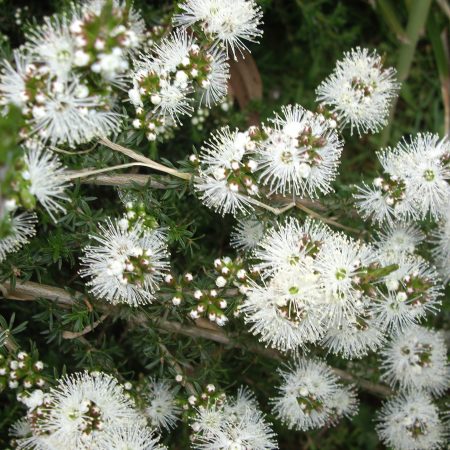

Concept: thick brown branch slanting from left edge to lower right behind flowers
[[3, 281, 392, 397]]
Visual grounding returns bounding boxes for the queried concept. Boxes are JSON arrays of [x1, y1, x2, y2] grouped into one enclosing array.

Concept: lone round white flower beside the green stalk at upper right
[[316, 47, 399, 134]]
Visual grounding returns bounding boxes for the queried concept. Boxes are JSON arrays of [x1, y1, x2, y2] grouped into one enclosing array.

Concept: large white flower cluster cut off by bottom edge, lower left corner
[[11, 372, 162, 450]]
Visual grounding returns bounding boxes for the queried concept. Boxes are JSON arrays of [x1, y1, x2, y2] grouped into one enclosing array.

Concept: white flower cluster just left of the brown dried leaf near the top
[[128, 30, 229, 140]]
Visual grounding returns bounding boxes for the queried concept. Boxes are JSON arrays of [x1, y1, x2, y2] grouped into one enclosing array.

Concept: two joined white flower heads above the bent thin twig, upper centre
[[195, 105, 343, 214]]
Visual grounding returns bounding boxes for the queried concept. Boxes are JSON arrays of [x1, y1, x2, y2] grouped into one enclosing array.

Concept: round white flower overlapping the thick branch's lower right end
[[271, 358, 356, 431]]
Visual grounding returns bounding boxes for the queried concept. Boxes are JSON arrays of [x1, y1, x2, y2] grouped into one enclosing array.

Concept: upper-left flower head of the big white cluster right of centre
[[253, 217, 332, 278]]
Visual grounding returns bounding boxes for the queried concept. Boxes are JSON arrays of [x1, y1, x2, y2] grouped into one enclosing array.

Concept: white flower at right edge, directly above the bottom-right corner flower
[[381, 326, 450, 395]]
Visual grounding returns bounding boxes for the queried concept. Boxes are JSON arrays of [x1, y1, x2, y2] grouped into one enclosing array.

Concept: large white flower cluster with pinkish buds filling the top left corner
[[0, 0, 144, 147]]
